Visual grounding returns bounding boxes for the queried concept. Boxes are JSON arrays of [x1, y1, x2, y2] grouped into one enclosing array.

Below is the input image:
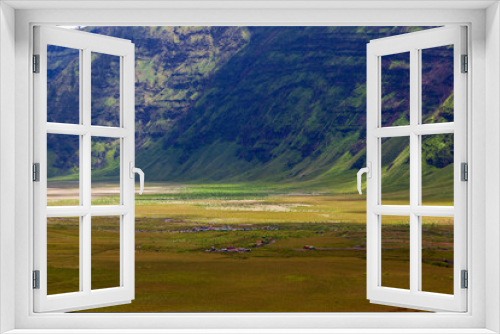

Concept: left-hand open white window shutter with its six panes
[[33, 26, 135, 312]]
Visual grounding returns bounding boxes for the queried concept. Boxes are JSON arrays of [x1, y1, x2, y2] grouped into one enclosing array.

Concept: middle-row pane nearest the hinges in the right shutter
[[422, 133, 454, 206]]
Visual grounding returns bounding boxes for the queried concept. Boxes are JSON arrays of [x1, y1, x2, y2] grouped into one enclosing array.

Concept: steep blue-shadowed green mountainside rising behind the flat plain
[[47, 27, 453, 196]]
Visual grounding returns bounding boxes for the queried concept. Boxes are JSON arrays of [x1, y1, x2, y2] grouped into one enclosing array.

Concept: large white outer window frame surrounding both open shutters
[[0, 0, 500, 333]]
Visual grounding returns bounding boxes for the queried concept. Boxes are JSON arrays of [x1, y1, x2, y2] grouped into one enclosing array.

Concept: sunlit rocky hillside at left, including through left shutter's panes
[[48, 27, 249, 179]]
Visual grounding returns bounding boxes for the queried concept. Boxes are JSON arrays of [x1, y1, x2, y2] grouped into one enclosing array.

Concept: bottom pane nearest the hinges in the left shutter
[[47, 217, 80, 295]]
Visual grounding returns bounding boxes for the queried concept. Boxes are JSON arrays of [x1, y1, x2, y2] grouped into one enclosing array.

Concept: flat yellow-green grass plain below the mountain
[[48, 184, 453, 312]]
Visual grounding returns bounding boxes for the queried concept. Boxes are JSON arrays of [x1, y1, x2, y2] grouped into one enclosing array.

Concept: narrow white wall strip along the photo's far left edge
[[0, 3, 15, 333]]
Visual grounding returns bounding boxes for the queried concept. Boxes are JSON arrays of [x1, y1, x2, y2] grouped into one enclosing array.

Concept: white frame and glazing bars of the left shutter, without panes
[[33, 26, 135, 312]]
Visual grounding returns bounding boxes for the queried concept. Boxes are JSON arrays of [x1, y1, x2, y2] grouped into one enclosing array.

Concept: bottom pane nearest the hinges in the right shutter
[[421, 217, 454, 295]]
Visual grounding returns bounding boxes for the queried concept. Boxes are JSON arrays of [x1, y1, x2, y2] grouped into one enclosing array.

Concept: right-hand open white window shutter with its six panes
[[363, 26, 468, 312]]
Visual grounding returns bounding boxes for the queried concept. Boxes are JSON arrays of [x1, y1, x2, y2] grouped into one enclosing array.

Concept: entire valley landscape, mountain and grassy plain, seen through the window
[[47, 27, 453, 312]]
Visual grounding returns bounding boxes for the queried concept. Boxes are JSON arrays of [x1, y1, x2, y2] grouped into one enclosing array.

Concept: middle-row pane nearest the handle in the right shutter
[[380, 137, 410, 205]]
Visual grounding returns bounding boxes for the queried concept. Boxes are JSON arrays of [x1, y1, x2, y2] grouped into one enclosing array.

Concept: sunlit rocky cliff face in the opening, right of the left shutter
[[84, 27, 254, 149]]
